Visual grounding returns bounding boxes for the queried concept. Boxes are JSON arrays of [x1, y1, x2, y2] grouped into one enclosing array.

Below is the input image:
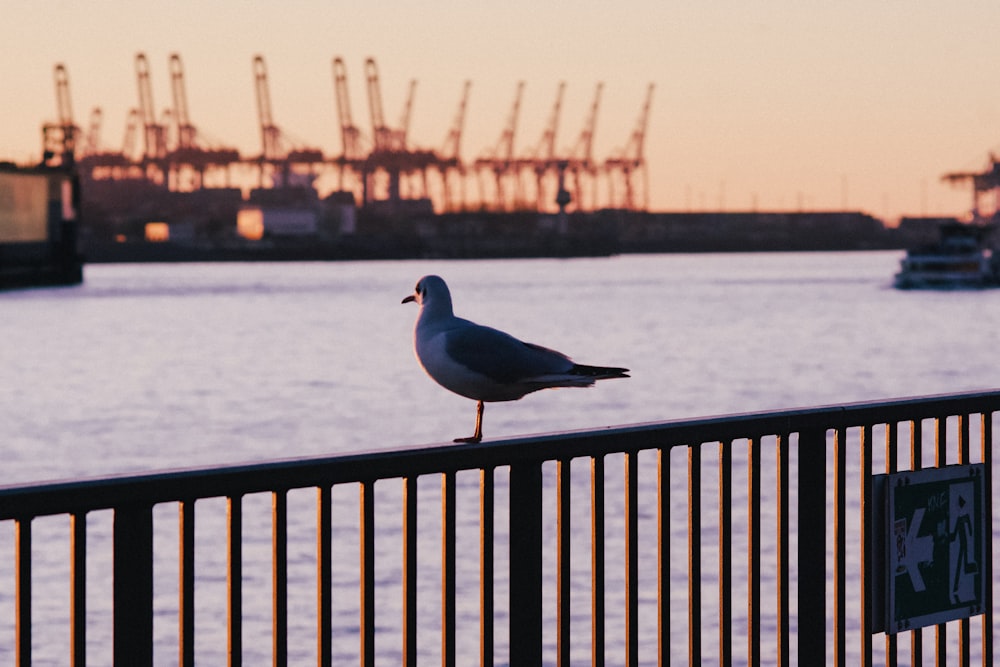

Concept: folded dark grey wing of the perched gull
[[445, 322, 573, 384]]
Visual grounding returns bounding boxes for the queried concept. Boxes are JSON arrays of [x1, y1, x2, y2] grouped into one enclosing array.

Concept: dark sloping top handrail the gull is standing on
[[0, 390, 1000, 520]]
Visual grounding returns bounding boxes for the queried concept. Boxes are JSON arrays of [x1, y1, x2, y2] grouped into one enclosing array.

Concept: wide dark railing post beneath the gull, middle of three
[[510, 461, 542, 667]]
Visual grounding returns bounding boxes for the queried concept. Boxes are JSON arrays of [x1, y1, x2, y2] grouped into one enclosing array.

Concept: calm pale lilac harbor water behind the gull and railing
[[0, 252, 1000, 664]]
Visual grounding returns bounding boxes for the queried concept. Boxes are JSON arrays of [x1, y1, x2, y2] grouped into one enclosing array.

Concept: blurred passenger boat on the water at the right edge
[[894, 222, 1000, 289]]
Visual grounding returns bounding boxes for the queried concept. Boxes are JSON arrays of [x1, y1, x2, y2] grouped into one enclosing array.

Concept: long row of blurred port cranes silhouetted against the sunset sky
[[42, 52, 654, 213]]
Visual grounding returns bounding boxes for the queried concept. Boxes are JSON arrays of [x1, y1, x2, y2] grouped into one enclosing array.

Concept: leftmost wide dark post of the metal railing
[[113, 505, 153, 667]]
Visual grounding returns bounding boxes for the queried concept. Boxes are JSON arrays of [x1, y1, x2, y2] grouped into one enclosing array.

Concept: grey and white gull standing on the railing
[[401, 276, 629, 443]]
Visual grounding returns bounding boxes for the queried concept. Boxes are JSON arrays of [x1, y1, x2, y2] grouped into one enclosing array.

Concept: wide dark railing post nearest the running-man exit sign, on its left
[[798, 430, 826, 665]]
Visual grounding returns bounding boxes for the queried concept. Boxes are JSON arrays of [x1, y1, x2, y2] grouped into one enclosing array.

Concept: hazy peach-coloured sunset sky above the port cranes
[[0, 0, 1000, 221]]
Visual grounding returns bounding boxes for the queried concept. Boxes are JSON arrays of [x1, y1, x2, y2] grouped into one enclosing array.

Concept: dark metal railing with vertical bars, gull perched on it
[[0, 392, 1000, 666]]
